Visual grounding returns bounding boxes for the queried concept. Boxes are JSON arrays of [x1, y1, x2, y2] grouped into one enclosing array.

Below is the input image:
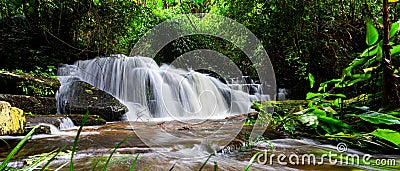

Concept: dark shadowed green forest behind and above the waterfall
[[0, 0, 390, 99]]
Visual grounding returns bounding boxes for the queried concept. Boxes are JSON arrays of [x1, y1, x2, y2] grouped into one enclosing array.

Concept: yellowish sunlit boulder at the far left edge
[[0, 101, 26, 135]]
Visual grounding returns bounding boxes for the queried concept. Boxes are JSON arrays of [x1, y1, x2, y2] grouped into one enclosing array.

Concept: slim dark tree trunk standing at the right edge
[[382, 0, 400, 107]]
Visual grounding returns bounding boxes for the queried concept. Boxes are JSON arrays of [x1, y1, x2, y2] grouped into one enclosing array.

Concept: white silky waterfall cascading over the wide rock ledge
[[57, 55, 262, 121]]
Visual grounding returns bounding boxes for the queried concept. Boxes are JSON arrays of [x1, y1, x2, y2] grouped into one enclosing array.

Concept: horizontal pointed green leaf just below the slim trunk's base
[[352, 112, 400, 125]]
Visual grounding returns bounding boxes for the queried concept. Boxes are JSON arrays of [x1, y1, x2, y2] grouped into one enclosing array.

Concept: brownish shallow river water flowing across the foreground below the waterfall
[[0, 119, 399, 171]]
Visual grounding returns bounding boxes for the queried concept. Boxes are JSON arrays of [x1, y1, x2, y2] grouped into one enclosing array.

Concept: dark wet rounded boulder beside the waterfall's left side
[[57, 81, 128, 121]]
